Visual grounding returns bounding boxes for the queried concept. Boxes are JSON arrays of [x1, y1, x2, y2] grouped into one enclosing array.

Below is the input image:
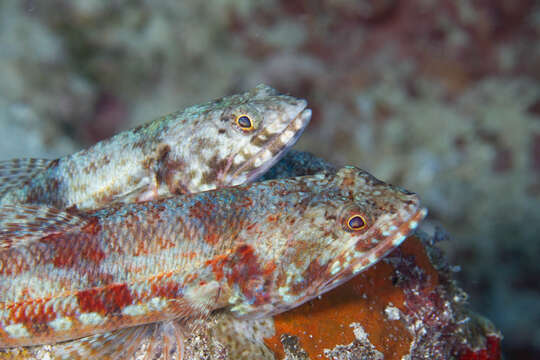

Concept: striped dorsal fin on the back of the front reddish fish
[[0, 205, 88, 250]]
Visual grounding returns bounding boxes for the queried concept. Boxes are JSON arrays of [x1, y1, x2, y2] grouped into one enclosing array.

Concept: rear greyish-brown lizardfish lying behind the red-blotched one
[[0, 85, 311, 209]]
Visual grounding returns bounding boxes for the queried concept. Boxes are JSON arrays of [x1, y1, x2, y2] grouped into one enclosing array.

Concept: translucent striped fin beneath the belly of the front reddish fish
[[50, 324, 153, 360]]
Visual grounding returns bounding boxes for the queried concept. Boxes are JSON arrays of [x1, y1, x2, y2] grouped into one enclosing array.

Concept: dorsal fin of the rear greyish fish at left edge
[[0, 159, 56, 197]]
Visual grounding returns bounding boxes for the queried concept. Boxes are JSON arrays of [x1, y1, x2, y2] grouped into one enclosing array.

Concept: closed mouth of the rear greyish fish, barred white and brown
[[229, 104, 311, 182]]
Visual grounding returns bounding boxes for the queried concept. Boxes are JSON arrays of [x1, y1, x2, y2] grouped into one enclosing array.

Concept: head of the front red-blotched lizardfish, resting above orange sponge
[[244, 167, 427, 315]]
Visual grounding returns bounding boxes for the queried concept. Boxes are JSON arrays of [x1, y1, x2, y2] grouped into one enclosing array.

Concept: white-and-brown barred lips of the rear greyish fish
[[227, 102, 311, 183]]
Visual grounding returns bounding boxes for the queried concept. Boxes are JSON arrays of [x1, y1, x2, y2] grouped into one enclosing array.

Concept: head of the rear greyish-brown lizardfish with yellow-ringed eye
[[178, 85, 311, 192]]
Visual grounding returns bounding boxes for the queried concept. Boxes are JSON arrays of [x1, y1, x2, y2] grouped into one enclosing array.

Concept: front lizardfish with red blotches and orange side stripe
[[0, 167, 425, 356]]
